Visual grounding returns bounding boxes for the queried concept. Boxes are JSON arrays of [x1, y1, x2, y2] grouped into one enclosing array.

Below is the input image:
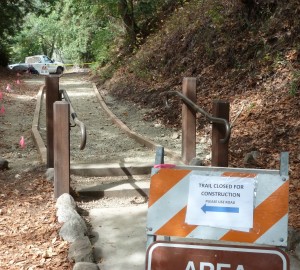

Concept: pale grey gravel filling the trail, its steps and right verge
[[34, 74, 209, 210]]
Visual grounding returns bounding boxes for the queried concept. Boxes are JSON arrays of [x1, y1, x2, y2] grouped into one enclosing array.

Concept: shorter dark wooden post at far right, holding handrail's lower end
[[211, 100, 230, 167]]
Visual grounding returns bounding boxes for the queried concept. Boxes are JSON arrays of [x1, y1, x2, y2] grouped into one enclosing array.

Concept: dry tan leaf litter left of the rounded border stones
[[0, 173, 72, 270]]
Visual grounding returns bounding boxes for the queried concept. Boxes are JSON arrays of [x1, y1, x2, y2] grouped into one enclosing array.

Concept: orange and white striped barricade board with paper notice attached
[[146, 152, 289, 247]]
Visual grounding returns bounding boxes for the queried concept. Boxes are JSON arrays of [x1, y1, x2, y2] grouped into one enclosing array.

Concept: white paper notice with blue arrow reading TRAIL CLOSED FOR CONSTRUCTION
[[185, 175, 255, 231]]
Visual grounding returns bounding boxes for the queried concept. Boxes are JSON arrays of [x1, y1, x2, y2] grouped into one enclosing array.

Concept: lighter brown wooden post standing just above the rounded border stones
[[53, 101, 70, 198]]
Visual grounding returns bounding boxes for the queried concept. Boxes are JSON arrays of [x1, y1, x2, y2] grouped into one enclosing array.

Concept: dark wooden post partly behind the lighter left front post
[[45, 75, 60, 168]]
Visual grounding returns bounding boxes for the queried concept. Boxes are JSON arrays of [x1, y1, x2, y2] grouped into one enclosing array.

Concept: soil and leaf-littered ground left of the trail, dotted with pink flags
[[0, 70, 72, 270]]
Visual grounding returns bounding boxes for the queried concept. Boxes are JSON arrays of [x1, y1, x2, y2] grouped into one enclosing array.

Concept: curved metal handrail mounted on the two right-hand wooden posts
[[166, 91, 231, 143]]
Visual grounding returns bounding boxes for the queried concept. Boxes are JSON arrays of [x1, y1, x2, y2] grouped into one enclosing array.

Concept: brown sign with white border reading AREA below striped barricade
[[146, 241, 290, 270]]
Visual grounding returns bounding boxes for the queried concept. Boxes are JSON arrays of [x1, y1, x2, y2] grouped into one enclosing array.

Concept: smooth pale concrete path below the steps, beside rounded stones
[[90, 203, 147, 270]]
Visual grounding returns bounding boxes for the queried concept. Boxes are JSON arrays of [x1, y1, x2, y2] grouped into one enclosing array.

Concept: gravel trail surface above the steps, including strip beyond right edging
[[40, 75, 207, 163]]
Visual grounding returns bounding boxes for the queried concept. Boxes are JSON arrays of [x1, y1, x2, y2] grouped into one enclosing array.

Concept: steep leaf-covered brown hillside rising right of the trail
[[99, 0, 300, 229]]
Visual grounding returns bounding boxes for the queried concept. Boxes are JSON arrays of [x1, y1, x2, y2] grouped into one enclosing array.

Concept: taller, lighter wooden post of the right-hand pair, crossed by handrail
[[182, 78, 197, 164]]
